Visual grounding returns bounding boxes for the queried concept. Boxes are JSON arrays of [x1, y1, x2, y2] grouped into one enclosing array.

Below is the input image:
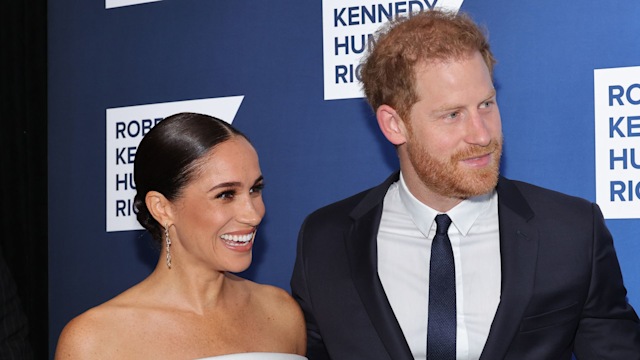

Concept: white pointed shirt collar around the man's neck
[[398, 172, 498, 237]]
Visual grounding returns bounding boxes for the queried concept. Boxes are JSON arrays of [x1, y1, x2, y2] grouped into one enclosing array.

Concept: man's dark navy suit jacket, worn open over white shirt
[[291, 173, 640, 360]]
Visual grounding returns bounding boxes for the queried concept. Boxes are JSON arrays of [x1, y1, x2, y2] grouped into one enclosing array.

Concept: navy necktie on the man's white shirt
[[427, 214, 456, 360]]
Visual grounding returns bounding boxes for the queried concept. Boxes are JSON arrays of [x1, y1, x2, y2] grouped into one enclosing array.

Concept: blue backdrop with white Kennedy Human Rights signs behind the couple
[[48, 0, 640, 352]]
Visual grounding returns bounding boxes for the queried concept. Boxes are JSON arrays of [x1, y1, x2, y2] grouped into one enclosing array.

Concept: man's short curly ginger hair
[[361, 10, 496, 118]]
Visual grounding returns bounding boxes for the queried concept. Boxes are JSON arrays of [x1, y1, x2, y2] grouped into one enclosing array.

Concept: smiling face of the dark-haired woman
[[170, 136, 265, 272]]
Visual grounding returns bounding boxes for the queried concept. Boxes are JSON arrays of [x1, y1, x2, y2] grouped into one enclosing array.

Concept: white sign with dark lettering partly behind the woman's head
[[106, 96, 244, 232]]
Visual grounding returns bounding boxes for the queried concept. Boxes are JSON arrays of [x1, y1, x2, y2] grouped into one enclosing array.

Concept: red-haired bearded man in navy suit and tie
[[291, 11, 640, 360]]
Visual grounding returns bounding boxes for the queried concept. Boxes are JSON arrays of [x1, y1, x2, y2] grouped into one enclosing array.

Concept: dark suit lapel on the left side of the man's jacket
[[345, 173, 413, 359]]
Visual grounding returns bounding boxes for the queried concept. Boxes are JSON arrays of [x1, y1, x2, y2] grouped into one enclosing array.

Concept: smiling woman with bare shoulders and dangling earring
[[56, 113, 306, 359]]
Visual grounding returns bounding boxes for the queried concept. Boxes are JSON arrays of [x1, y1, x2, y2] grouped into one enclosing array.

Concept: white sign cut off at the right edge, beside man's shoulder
[[593, 66, 640, 219]]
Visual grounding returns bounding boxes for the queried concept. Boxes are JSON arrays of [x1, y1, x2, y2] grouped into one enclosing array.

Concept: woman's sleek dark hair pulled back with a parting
[[133, 113, 247, 241]]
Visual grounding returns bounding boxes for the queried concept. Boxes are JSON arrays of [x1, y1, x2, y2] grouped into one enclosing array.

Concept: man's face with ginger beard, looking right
[[401, 53, 502, 199]]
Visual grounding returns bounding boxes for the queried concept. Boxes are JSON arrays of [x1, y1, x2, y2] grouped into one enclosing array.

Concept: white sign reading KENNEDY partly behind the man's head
[[322, 0, 463, 100]]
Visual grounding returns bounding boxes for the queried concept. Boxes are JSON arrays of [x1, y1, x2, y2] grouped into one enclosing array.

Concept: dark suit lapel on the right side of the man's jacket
[[480, 178, 538, 360]]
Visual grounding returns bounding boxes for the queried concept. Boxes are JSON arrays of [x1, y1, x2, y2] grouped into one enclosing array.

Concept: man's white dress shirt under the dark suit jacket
[[377, 175, 501, 360]]
